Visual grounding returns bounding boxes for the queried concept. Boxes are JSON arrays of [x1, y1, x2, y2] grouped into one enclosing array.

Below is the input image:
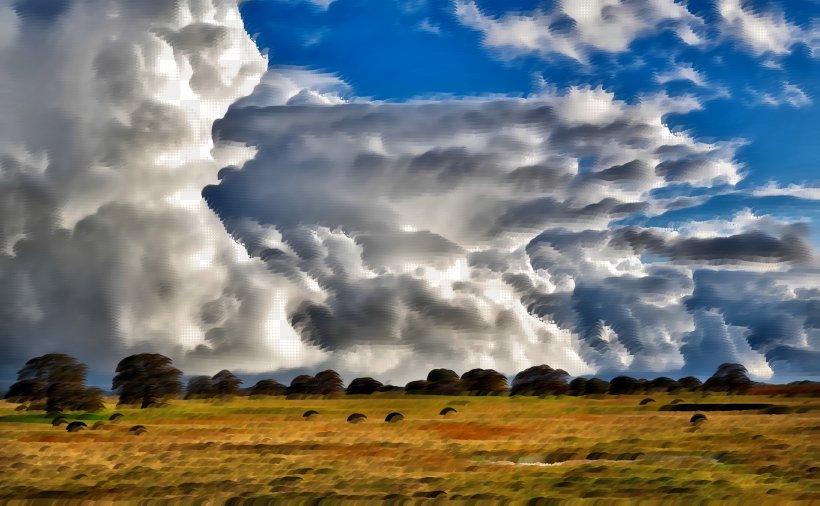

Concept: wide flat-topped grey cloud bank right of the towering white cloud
[[203, 76, 813, 375]]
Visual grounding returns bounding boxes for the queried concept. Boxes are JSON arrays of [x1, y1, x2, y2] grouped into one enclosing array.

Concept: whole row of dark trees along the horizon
[[4, 353, 752, 413]]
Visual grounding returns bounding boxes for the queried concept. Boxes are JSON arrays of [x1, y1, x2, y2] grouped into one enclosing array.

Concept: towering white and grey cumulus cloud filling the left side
[[0, 0, 326, 377]]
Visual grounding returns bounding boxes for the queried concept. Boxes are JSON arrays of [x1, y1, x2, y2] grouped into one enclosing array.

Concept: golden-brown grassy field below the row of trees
[[0, 393, 820, 504]]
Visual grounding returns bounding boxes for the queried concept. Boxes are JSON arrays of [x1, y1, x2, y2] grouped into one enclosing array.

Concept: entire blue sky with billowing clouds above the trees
[[0, 0, 820, 386]]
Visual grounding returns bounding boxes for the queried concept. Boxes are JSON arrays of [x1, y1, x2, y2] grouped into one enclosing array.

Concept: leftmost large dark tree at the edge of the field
[[5, 353, 103, 413]]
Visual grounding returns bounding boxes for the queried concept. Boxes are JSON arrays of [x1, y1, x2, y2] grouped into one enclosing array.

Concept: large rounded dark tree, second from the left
[[112, 353, 182, 408]]
